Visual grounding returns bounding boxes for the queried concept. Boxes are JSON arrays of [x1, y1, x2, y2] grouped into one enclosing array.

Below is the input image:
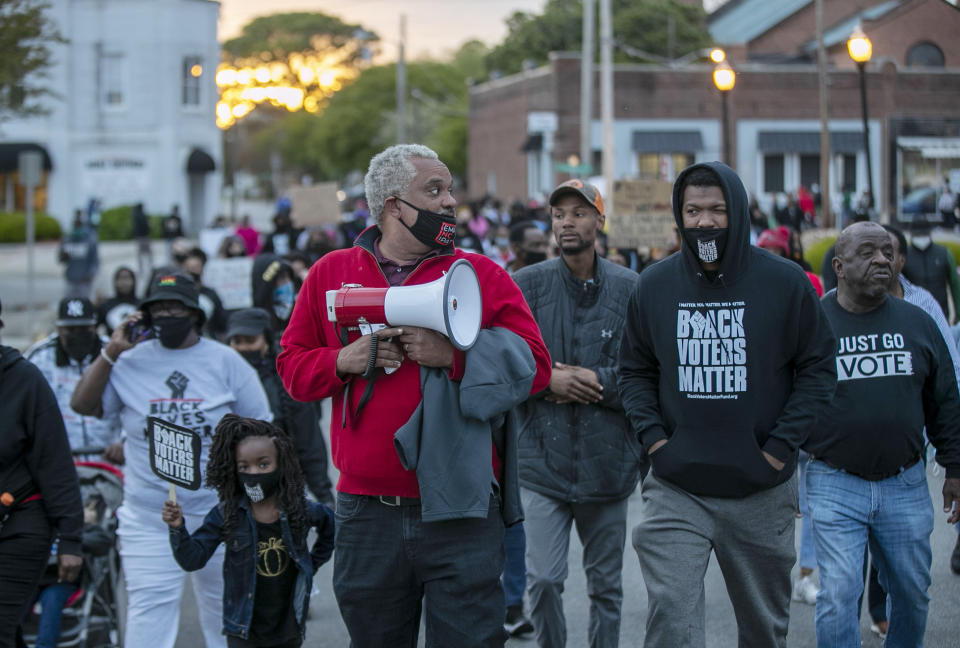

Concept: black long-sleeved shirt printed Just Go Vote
[[805, 291, 960, 476]]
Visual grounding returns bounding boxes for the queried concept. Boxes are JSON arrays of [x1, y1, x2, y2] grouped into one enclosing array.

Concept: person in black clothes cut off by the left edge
[[0, 298, 83, 646]]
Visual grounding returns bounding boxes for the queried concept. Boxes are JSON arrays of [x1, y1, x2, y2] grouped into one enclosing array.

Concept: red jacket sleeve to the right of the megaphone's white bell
[[470, 257, 551, 394]]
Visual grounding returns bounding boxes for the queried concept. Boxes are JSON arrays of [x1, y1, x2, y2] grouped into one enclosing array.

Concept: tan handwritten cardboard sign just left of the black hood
[[607, 180, 676, 248]]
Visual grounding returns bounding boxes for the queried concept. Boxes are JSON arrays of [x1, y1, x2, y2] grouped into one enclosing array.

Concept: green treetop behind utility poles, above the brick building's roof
[[486, 0, 711, 74]]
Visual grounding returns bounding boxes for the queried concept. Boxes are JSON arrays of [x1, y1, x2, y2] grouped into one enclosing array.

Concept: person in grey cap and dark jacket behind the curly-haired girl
[[227, 308, 333, 506]]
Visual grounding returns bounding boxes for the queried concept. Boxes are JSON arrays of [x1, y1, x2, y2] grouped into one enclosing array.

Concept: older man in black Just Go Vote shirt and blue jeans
[[805, 223, 960, 647]]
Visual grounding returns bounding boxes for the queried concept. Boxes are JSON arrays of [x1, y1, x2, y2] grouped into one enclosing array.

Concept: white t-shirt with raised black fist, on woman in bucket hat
[[102, 338, 273, 515]]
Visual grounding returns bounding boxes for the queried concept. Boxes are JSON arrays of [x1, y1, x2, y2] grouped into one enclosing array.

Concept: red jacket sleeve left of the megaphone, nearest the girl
[[277, 260, 346, 401]]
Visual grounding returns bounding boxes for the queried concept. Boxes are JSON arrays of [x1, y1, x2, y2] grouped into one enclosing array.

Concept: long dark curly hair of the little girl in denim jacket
[[206, 414, 309, 542]]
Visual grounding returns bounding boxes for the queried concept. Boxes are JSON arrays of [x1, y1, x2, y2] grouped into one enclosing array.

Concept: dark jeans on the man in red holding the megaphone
[[333, 493, 506, 648]]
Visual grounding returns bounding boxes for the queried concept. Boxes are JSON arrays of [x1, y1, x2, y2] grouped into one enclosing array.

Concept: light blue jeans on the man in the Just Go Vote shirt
[[807, 460, 933, 648]]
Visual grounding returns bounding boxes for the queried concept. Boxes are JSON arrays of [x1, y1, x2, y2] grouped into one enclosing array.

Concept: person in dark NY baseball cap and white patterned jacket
[[26, 297, 123, 460]]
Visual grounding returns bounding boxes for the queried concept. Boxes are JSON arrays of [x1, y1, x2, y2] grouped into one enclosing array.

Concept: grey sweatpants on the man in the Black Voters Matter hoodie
[[633, 473, 797, 648]]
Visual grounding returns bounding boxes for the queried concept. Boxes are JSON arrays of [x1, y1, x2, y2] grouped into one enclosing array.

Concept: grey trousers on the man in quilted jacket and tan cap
[[520, 488, 627, 648]]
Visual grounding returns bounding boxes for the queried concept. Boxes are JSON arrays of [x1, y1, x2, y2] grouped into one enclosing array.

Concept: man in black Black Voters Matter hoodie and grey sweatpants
[[619, 162, 836, 647]]
